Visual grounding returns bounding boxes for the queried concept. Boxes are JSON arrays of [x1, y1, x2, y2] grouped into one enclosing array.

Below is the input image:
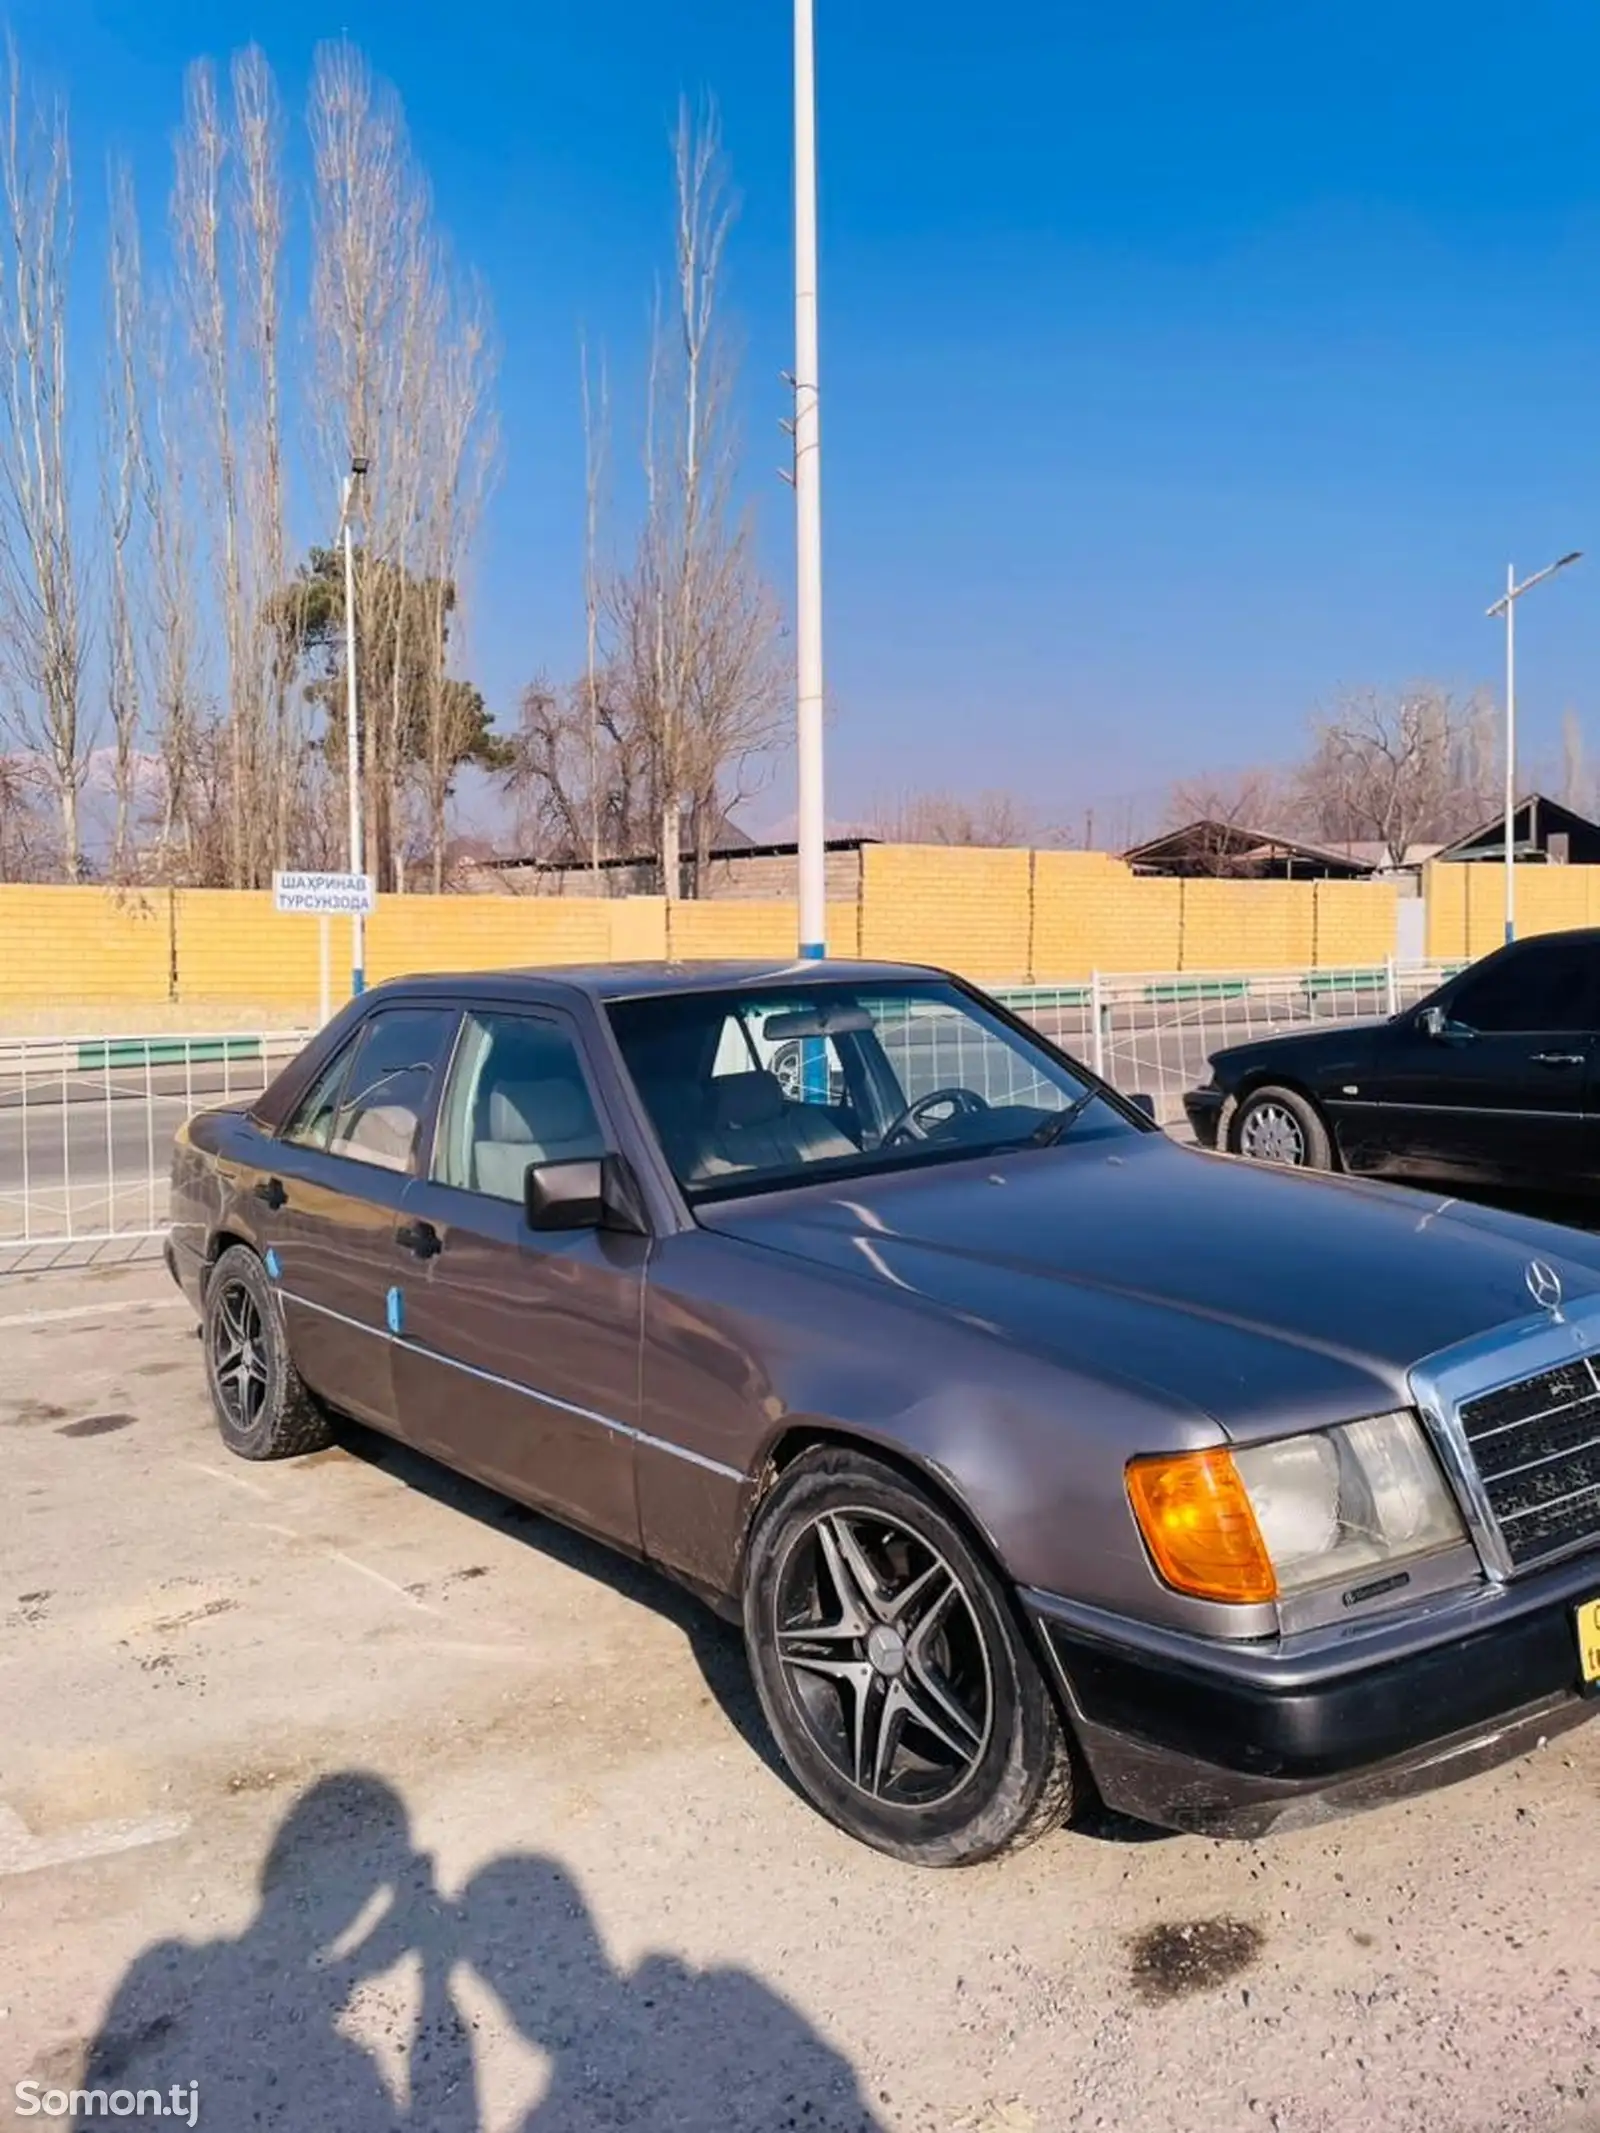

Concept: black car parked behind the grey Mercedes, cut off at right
[[1184, 930, 1600, 1194]]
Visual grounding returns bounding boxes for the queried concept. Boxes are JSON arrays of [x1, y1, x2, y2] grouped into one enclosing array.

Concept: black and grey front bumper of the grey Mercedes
[[1024, 1557, 1600, 1837]]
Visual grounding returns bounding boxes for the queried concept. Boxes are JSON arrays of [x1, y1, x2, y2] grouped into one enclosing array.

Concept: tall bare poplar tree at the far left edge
[[0, 41, 92, 879]]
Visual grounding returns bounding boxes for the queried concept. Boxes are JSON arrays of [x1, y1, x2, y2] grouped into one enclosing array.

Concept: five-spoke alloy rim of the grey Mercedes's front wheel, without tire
[[774, 1508, 994, 1807]]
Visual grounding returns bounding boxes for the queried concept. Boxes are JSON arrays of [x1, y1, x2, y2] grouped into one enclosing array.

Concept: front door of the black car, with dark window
[[1367, 936, 1600, 1186]]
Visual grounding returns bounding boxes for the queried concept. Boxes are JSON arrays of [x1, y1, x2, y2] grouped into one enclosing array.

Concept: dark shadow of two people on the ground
[[81, 1770, 879, 2133]]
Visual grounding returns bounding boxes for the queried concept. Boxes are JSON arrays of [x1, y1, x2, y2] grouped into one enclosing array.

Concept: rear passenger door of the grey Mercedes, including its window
[[252, 1005, 457, 1429]]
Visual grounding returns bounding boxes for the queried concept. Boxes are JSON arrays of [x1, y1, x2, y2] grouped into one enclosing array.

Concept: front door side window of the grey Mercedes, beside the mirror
[[433, 1013, 606, 1203]]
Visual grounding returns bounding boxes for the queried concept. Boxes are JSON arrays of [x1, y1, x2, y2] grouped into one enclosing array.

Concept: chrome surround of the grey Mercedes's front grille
[[1410, 1297, 1600, 1585]]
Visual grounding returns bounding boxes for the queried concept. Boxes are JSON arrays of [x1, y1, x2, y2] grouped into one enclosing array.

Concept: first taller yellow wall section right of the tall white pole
[[862, 845, 1033, 979]]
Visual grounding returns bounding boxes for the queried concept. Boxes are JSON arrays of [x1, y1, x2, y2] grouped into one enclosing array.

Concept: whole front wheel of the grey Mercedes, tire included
[[745, 1446, 1077, 1866]]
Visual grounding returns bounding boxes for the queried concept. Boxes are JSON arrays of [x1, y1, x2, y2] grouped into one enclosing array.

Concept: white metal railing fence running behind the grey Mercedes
[[0, 964, 1449, 1271]]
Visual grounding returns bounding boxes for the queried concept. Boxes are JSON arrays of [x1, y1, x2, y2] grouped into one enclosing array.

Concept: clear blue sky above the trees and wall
[[11, 0, 1600, 823]]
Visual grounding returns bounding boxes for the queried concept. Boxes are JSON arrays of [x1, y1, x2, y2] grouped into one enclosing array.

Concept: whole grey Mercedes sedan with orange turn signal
[[169, 962, 1600, 1864]]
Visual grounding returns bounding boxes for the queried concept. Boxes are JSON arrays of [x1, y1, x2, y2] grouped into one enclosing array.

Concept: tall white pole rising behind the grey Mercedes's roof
[[794, 0, 828, 956]]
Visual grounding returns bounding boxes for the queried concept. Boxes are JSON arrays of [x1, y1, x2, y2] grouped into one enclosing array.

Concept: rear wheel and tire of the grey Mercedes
[[201, 1244, 333, 1459]]
